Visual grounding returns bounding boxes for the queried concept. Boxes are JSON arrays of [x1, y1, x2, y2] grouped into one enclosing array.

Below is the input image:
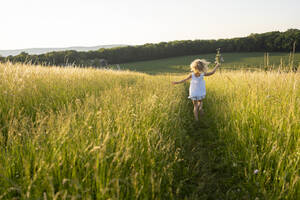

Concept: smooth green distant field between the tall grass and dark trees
[[116, 52, 300, 74]]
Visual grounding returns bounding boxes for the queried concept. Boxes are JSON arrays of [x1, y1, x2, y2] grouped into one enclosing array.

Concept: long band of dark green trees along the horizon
[[0, 29, 300, 67]]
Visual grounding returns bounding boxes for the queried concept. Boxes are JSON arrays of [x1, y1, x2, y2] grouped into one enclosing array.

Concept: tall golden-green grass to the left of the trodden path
[[0, 63, 191, 199]]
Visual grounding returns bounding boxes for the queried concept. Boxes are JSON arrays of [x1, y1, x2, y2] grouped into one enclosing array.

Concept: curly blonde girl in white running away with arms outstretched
[[172, 59, 220, 121]]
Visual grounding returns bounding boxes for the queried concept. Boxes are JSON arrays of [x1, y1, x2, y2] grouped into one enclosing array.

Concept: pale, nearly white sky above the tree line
[[0, 0, 300, 50]]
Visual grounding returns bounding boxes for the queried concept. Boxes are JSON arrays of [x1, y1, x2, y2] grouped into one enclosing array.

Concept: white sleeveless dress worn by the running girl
[[188, 73, 206, 100]]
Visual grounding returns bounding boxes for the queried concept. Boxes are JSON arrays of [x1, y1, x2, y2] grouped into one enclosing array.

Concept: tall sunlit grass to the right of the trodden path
[[206, 72, 300, 199]]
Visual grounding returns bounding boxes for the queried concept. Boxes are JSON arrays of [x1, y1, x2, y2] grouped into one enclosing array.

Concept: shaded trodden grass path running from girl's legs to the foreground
[[172, 84, 232, 199]]
